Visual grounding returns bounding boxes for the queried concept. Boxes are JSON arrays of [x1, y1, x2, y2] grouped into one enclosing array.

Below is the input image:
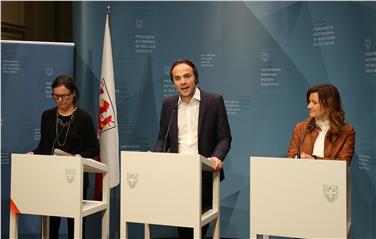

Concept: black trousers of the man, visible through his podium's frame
[[177, 172, 213, 239]]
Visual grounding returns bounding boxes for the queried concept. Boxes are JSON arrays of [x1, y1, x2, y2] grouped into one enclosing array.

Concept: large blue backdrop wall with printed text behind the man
[[74, 1, 376, 239]]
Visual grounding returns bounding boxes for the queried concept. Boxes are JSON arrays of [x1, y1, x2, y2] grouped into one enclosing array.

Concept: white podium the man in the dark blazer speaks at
[[120, 151, 220, 238]]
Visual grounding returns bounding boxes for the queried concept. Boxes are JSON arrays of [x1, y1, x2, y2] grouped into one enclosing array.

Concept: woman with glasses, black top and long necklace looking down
[[32, 74, 99, 238]]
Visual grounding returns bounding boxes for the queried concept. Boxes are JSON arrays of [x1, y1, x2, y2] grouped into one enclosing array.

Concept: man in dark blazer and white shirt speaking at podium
[[154, 59, 232, 238]]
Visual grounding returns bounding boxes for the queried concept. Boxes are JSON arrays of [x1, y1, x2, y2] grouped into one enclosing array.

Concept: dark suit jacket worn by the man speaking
[[154, 89, 232, 179]]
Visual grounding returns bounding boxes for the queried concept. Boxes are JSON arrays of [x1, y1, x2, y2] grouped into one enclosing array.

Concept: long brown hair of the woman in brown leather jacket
[[307, 84, 345, 141]]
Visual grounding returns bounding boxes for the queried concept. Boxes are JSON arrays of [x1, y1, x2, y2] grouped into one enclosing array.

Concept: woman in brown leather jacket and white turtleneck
[[288, 84, 355, 165]]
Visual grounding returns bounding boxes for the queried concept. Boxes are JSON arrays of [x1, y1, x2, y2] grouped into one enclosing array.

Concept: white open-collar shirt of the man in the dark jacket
[[178, 87, 201, 154]]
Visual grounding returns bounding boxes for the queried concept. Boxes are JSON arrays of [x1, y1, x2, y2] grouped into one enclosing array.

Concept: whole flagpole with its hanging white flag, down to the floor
[[96, 5, 120, 238]]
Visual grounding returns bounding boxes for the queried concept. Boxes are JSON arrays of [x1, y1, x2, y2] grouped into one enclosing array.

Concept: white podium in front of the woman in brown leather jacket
[[250, 156, 351, 239]]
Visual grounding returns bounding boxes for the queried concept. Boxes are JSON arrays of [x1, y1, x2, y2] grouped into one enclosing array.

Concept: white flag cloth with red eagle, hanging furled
[[98, 14, 119, 188]]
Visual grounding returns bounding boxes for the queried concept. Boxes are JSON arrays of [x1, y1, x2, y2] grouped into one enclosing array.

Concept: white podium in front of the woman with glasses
[[9, 154, 110, 239]]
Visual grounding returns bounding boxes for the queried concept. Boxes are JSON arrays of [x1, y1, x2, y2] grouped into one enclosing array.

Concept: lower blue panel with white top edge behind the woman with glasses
[[1, 41, 74, 238]]
